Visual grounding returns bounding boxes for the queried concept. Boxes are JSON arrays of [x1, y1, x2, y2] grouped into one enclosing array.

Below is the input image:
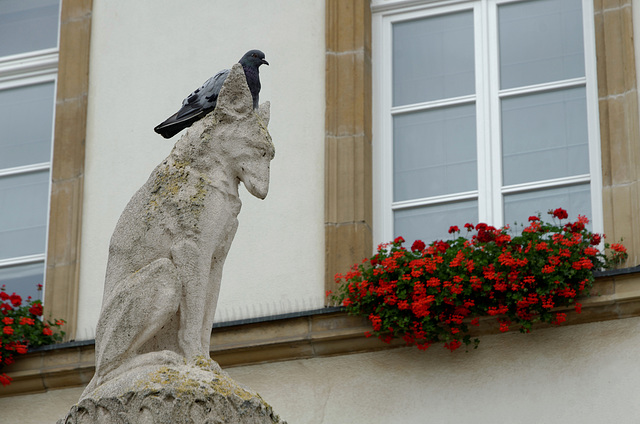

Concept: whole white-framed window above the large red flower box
[[373, 0, 602, 242]]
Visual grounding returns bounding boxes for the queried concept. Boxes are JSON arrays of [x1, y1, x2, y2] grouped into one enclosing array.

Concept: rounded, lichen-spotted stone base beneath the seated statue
[[58, 361, 286, 424]]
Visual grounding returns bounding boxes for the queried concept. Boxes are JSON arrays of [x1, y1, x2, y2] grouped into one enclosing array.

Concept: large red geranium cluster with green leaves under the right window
[[332, 208, 626, 351]]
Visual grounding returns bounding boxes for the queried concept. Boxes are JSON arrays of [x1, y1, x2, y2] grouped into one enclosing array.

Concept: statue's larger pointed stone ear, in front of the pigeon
[[214, 63, 253, 121]]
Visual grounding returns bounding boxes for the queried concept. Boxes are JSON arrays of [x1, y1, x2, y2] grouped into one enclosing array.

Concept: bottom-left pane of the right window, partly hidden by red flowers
[[393, 200, 478, 246]]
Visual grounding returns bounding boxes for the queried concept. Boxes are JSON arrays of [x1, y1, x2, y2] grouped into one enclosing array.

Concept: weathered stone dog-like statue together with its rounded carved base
[[63, 64, 281, 423]]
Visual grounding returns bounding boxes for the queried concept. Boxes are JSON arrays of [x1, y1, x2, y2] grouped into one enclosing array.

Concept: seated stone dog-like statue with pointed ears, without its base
[[81, 64, 275, 399]]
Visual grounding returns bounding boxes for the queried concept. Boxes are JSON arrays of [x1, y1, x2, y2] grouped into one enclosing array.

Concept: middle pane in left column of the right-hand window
[[393, 105, 478, 202]]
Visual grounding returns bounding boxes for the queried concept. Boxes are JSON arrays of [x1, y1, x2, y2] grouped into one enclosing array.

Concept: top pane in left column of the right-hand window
[[393, 11, 475, 106]]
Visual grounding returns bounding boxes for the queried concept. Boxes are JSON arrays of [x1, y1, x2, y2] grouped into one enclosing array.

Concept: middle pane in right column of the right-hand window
[[502, 87, 589, 185]]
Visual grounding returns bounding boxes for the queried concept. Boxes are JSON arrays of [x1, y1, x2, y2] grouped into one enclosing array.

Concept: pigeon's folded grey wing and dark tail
[[154, 69, 229, 138]]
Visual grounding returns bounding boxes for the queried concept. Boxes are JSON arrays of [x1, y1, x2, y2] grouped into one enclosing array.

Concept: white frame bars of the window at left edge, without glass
[[0, 46, 60, 294]]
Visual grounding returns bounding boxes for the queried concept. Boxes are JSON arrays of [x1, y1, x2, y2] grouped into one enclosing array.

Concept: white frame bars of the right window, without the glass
[[371, 0, 604, 245]]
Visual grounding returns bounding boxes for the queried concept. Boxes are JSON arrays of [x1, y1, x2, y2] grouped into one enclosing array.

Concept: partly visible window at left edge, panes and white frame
[[0, 0, 60, 299]]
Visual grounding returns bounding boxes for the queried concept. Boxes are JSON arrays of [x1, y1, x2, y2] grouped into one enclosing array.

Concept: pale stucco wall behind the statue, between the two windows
[[77, 0, 325, 340]]
